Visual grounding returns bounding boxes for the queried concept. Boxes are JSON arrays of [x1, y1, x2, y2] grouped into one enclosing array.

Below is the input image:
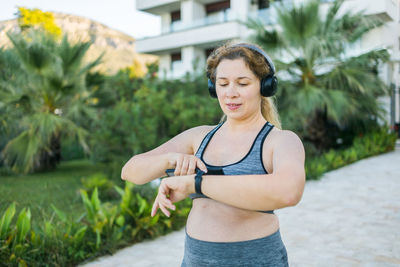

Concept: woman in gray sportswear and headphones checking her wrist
[[121, 44, 305, 267]]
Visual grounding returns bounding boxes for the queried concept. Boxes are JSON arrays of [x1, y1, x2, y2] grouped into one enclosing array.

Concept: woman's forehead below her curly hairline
[[216, 58, 255, 79]]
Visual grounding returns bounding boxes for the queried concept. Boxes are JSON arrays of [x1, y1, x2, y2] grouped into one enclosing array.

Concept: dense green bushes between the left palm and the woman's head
[[92, 72, 220, 166]]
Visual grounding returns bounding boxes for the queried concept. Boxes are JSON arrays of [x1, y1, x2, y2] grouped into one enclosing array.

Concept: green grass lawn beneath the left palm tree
[[0, 160, 110, 222]]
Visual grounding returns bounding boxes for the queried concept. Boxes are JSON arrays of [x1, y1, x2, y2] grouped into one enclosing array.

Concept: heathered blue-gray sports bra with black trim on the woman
[[189, 122, 274, 214]]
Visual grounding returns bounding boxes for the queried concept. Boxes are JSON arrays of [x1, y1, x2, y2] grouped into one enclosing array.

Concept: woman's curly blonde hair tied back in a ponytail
[[207, 43, 282, 129]]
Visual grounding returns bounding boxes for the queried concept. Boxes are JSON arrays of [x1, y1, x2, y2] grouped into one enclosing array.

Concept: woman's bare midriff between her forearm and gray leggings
[[186, 198, 279, 242]]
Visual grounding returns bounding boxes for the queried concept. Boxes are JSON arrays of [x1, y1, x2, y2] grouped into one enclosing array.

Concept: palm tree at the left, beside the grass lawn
[[0, 30, 100, 173]]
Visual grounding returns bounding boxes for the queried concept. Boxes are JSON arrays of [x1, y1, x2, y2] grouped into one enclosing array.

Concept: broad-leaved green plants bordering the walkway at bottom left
[[0, 183, 191, 266]]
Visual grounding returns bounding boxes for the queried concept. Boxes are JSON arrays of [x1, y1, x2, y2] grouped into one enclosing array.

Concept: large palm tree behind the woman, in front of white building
[[246, 0, 389, 150]]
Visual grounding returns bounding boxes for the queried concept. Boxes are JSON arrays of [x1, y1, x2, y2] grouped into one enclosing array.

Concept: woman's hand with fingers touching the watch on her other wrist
[[168, 152, 207, 176]]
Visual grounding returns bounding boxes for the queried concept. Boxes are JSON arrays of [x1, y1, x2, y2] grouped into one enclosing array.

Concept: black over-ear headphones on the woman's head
[[207, 44, 278, 98]]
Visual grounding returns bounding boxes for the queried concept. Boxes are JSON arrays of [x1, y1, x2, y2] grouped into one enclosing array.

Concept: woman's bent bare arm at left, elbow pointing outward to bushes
[[121, 126, 207, 185]]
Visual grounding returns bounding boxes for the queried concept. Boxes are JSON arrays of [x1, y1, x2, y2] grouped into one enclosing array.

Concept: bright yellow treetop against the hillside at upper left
[[18, 7, 62, 37]]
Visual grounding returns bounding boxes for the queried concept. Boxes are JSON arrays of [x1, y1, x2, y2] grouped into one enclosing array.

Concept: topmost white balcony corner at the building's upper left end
[[136, 0, 181, 15]]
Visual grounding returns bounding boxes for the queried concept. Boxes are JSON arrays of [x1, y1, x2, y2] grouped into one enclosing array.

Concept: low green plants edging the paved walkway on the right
[[306, 127, 397, 180]]
